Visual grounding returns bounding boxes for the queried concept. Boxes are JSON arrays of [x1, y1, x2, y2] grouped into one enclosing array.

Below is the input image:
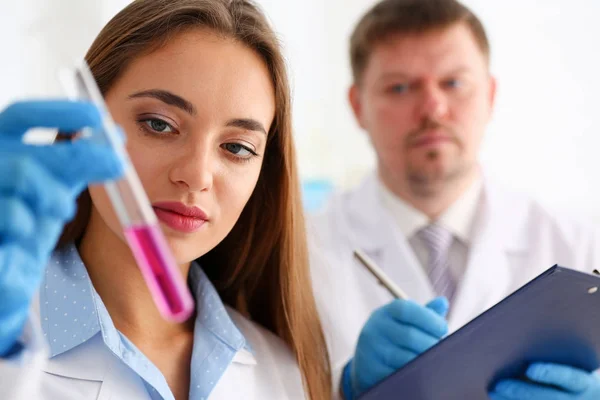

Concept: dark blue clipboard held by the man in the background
[[360, 265, 600, 400]]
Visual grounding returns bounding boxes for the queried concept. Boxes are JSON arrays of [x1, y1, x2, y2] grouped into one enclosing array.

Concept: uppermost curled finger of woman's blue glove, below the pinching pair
[[0, 154, 75, 222]]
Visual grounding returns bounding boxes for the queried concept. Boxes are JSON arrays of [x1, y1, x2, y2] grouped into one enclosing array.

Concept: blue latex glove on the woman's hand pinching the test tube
[[0, 101, 123, 357]]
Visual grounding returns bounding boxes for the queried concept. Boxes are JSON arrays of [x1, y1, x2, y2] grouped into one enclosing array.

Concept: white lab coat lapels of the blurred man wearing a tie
[[331, 171, 530, 330]]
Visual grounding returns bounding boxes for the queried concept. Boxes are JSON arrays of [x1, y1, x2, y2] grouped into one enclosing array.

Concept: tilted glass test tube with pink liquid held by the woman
[[60, 62, 194, 322]]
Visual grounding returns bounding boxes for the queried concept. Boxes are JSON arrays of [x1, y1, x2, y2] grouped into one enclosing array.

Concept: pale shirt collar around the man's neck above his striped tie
[[378, 178, 483, 244]]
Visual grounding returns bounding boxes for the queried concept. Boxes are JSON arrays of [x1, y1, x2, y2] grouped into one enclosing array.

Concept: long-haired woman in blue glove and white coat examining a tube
[[0, 0, 332, 400]]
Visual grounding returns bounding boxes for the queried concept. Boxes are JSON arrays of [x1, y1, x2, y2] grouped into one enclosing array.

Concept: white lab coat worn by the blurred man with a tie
[[308, 175, 600, 380]]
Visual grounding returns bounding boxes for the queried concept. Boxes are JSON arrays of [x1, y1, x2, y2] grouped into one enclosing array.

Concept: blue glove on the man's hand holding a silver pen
[[342, 297, 448, 400]]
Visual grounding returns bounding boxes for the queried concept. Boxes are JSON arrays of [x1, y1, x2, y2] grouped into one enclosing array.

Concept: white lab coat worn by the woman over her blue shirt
[[0, 308, 305, 400]]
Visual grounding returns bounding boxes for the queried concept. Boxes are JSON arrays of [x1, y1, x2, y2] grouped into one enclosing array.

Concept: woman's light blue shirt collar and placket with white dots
[[40, 245, 255, 399]]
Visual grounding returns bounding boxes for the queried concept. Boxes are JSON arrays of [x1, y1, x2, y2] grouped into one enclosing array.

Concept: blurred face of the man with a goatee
[[350, 23, 495, 195]]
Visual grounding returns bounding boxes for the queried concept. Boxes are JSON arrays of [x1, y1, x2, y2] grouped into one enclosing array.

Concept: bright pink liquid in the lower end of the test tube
[[124, 225, 194, 322]]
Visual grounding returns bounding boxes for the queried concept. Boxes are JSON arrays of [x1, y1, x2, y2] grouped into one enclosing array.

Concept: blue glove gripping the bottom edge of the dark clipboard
[[490, 363, 600, 400]]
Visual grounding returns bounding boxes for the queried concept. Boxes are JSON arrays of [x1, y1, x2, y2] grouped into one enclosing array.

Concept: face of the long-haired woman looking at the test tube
[[90, 30, 275, 264]]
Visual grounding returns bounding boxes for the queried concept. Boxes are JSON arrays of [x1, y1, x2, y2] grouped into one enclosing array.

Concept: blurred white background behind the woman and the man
[[0, 0, 600, 222]]
